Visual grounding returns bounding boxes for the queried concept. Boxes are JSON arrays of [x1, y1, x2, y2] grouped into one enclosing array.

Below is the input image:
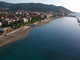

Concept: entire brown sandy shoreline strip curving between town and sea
[[0, 16, 63, 47]]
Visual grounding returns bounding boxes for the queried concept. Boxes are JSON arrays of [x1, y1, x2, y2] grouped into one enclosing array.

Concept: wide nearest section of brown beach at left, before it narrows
[[0, 27, 32, 47]]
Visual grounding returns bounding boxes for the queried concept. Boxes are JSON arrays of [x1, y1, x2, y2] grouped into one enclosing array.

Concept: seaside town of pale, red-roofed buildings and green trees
[[0, 11, 64, 34]]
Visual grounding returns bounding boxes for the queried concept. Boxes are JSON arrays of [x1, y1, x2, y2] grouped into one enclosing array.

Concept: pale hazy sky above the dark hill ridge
[[0, 0, 80, 12]]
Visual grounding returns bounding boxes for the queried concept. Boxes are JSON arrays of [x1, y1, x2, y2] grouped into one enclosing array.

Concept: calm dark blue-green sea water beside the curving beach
[[0, 17, 80, 60]]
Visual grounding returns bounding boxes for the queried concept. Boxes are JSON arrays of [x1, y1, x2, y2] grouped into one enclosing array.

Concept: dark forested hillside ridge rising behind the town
[[0, 1, 71, 13]]
